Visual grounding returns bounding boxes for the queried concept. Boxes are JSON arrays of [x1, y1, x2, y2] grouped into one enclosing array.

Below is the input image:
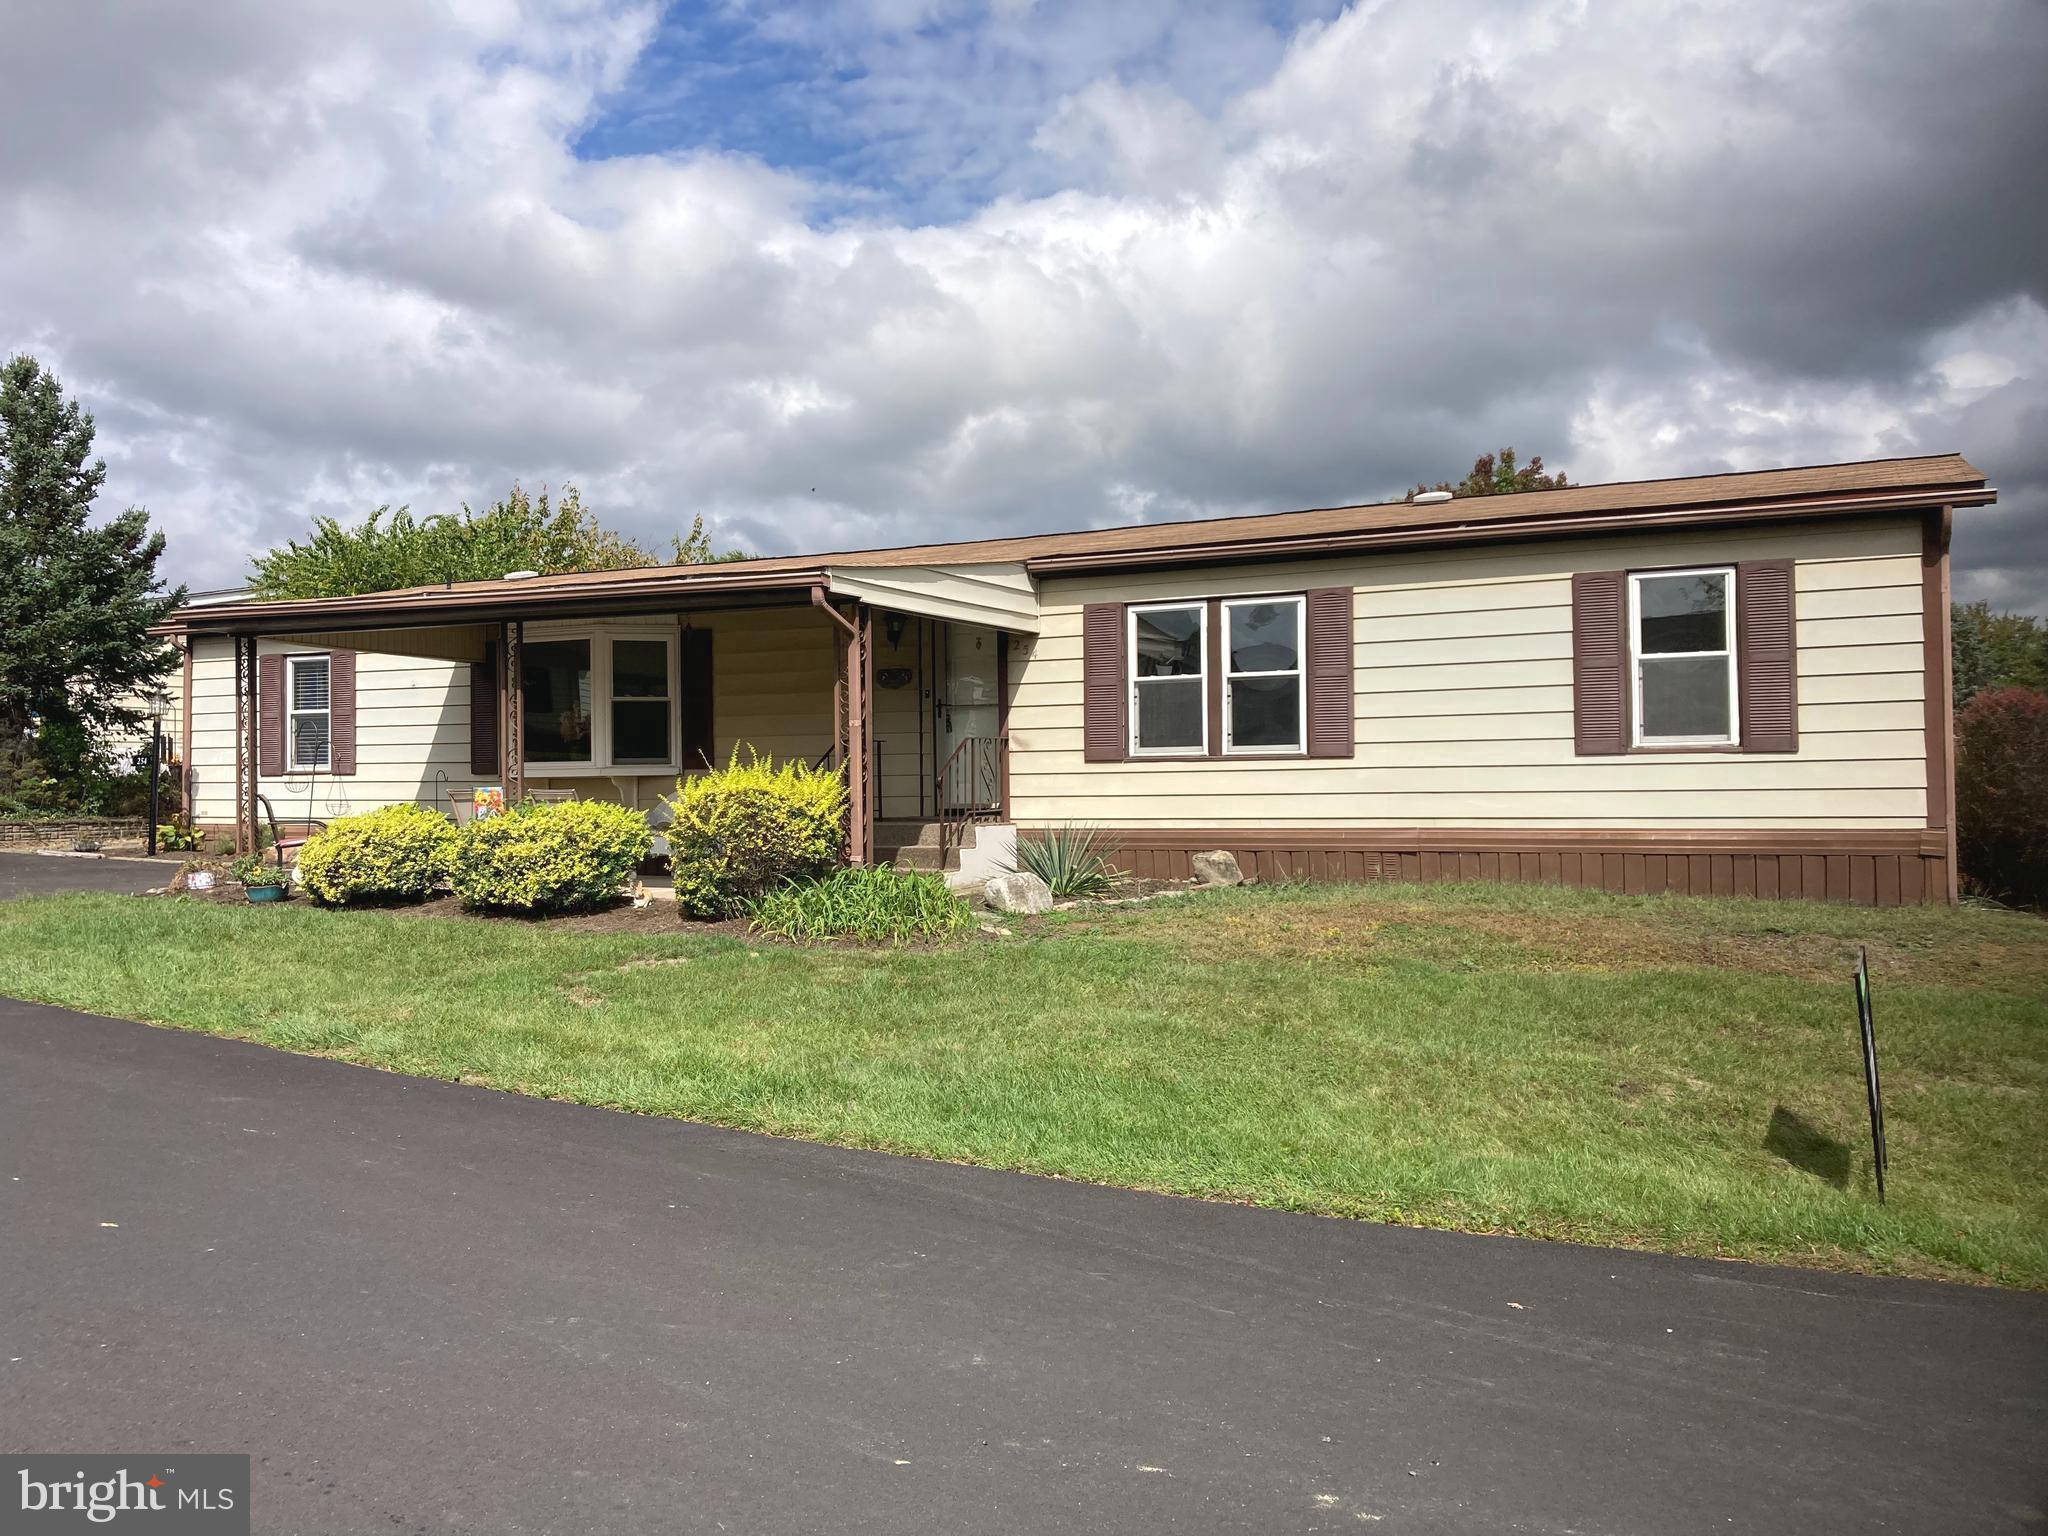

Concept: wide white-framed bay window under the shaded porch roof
[[520, 629, 678, 778]]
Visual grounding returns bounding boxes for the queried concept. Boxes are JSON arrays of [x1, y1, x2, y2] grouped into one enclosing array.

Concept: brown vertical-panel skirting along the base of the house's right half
[[1089, 827, 1950, 907]]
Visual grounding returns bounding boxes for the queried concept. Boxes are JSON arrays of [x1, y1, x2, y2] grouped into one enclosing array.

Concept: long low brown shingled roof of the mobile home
[[178, 453, 1995, 629]]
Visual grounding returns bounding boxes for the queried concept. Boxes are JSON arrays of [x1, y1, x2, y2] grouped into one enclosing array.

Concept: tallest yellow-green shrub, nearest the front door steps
[[666, 748, 846, 918]]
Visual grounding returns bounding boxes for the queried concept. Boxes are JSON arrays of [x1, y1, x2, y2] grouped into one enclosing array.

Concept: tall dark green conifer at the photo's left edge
[[0, 356, 184, 809]]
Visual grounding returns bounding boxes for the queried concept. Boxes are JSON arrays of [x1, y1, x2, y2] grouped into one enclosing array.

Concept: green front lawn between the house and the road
[[0, 887, 2048, 1288]]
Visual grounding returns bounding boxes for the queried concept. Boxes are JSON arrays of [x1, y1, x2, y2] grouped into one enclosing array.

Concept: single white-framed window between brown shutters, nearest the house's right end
[[1628, 565, 1737, 748]]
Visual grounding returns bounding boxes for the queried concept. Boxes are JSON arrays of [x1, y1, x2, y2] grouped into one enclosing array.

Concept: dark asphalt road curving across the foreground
[[0, 1003, 2048, 1536]]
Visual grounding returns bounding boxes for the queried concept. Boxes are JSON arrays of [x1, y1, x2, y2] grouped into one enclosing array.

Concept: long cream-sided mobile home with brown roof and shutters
[[176, 455, 1995, 903]]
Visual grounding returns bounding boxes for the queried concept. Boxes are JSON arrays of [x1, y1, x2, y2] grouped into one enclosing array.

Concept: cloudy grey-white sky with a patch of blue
[[0, 0, 2048, 610]]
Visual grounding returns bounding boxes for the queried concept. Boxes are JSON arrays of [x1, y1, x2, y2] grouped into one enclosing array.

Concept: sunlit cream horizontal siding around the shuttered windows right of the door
[[1010, 518, 1927, 827]]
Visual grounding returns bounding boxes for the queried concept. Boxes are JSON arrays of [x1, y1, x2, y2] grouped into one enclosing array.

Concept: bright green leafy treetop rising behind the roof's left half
[[250, 485, 745, 598]]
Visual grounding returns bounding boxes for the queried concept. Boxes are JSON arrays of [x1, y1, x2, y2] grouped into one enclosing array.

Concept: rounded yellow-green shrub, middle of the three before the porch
[[453, 801, 653, 911]]
